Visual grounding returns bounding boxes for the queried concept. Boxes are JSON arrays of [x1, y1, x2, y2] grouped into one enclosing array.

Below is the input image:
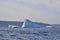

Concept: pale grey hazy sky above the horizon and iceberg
[[0, 0, 60, 24]]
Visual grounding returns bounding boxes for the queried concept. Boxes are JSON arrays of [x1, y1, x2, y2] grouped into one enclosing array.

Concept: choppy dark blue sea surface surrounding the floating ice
[[0, 21, 60, 40]]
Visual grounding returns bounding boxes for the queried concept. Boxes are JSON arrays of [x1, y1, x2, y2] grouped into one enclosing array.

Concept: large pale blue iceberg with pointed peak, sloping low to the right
[[22, 19, 51, 28]]
